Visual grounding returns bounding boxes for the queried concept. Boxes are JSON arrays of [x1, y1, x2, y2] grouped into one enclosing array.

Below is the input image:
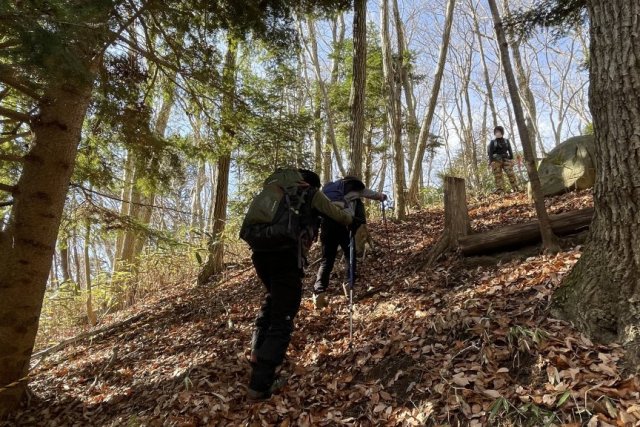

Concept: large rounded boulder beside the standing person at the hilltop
[[529, 135, 596, 196]]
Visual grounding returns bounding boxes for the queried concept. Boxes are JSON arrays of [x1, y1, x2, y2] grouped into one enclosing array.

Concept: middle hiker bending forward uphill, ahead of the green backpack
[[313, 176, 387, 309]]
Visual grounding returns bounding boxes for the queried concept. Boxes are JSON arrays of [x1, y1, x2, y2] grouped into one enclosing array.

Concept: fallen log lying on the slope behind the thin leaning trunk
[[458, 208, 594, 255]]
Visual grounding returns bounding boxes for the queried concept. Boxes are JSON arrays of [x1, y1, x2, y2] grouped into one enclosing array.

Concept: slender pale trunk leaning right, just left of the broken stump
[[407, 0, 456, 206]]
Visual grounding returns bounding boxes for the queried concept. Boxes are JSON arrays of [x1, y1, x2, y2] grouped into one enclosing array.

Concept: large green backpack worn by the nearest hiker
[[240, 169, 315, 251]]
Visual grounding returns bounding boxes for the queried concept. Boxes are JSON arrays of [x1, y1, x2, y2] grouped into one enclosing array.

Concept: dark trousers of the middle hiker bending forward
[[313, 218, 349, 294]]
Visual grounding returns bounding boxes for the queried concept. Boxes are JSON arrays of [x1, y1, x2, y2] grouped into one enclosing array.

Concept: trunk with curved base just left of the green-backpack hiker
[[198, 35, 239, 286]]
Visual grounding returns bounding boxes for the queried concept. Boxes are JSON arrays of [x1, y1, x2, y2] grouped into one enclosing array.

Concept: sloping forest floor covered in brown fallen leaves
[[6, 193, 640, 426]]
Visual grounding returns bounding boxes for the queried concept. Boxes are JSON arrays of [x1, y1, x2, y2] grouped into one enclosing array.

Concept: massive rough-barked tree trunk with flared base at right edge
[[554, 0, 640, 369]]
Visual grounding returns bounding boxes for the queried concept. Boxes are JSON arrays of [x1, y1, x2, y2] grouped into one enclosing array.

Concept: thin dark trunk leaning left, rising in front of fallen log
[[489, 0, 560, 252]]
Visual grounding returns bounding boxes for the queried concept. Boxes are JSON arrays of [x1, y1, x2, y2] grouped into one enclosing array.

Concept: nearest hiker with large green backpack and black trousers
[[240, 169, 353, 399]]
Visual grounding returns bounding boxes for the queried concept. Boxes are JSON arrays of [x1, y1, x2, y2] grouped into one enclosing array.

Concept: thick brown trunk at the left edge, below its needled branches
[[0, 82, 91, 418]]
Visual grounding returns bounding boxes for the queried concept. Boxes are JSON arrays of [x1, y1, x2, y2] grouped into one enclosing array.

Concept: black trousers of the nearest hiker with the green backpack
[[249, 249, 303, 392]]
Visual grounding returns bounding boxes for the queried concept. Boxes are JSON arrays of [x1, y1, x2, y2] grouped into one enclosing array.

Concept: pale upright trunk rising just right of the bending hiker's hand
[[380, 0, 406, 220]]
